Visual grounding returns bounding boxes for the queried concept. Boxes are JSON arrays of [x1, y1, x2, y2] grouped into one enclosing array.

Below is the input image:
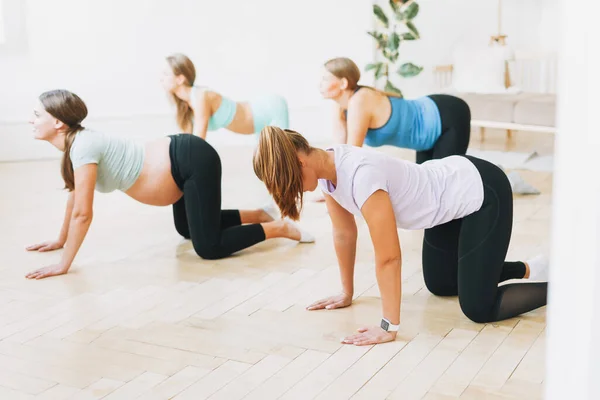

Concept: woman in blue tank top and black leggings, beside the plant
[[320, 58, 471, 164]]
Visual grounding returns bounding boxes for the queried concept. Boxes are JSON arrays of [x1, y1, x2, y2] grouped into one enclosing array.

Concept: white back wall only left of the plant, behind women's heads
[[0, 0, 373, 159]]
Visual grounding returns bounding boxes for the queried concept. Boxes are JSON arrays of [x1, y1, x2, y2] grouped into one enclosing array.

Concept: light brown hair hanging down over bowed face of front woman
[[253, 126, 314, 220]]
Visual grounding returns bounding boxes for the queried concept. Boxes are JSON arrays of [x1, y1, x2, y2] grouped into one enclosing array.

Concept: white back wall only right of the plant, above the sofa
[[377, 0, 559, 97]]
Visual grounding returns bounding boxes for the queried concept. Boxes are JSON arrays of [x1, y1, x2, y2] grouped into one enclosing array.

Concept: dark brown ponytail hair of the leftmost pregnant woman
[[39, 89, 88, 191]]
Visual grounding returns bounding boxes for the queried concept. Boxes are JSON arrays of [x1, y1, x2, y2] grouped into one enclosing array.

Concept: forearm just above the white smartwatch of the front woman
[[376, 258, 402, 325]]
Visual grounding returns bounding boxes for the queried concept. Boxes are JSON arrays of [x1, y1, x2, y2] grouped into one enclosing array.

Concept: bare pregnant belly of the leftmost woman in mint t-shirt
[[126, 137, 183, 206]]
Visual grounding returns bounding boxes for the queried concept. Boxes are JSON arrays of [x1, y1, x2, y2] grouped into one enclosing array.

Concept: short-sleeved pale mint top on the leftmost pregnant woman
[[69, 129, 144, 193]]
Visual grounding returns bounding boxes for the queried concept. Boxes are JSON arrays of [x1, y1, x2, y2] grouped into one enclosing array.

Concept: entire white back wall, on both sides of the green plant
[[0, 0, 558, 160]]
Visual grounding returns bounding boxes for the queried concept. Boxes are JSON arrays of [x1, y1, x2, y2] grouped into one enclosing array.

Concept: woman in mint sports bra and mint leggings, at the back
[[161, 53, 289, 139]]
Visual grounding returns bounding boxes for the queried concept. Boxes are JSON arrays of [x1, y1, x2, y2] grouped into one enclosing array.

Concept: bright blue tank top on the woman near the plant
[[350, 88, 442, 151]]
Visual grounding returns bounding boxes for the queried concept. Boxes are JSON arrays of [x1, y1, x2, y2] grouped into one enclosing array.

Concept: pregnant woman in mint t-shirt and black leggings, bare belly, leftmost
[[27, 90, 314, 279]]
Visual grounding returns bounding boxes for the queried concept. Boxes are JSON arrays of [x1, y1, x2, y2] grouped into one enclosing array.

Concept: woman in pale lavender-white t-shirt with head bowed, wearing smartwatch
[[254, 126, 548, 345]]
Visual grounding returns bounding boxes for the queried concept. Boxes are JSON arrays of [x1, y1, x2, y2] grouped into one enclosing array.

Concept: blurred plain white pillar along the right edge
[[545, 0, 600, 400]]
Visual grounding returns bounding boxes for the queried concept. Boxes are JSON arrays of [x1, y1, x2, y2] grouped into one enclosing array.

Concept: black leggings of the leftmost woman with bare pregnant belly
[[169, 133, 265, 260]]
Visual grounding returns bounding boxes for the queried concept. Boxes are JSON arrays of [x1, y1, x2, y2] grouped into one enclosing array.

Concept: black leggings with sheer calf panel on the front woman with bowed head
[[423, 156, 548, 322]]
